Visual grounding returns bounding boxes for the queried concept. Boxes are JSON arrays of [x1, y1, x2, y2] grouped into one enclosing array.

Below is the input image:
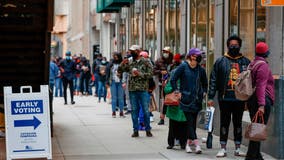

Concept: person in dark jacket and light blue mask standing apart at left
[[60, 51, 76, 105]]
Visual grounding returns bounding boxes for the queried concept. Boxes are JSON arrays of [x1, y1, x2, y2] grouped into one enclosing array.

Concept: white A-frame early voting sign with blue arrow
[[4, 85, 52, 160]]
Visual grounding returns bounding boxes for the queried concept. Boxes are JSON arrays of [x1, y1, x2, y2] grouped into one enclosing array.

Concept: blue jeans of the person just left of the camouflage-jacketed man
[[110, 81, 124, 112]]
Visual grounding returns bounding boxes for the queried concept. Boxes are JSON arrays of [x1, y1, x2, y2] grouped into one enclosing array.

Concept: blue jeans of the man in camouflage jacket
[[129, 91, 151, 131]]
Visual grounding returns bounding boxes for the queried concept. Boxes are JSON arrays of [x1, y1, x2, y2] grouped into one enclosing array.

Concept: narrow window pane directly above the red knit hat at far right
[[256, 0, 266, 42]]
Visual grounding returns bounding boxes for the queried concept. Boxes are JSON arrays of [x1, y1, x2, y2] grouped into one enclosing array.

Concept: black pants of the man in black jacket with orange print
[[219, 101, 244, 145]]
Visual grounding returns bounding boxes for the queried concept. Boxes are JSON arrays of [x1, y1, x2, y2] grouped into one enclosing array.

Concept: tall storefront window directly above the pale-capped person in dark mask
[[164, 0, 181, 52]]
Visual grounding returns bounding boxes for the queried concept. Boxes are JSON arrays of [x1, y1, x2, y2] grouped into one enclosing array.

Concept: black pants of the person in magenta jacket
[[246, 96, 272, 160]]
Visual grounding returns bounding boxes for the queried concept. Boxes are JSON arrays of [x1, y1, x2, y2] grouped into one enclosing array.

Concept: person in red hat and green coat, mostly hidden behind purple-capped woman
[[164, 54, 187, 149]]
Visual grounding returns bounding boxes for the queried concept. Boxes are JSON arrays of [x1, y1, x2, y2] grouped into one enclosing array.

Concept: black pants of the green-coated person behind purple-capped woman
[[168, 119, 187, 147]]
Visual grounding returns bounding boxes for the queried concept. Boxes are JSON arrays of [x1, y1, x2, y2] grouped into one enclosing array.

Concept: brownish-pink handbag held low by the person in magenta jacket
[[245, 111, 267, 141]]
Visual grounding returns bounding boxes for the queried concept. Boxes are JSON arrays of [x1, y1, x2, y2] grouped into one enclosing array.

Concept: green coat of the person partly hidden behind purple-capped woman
[[164, 75, 186, 122]]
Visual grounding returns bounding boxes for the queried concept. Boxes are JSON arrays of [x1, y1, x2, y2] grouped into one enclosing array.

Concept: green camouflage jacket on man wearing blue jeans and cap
[[118, 57, 153, 91]]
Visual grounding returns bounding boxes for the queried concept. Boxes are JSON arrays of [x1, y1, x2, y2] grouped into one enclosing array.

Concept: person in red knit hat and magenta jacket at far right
[[245, 42, 275, 160]]
